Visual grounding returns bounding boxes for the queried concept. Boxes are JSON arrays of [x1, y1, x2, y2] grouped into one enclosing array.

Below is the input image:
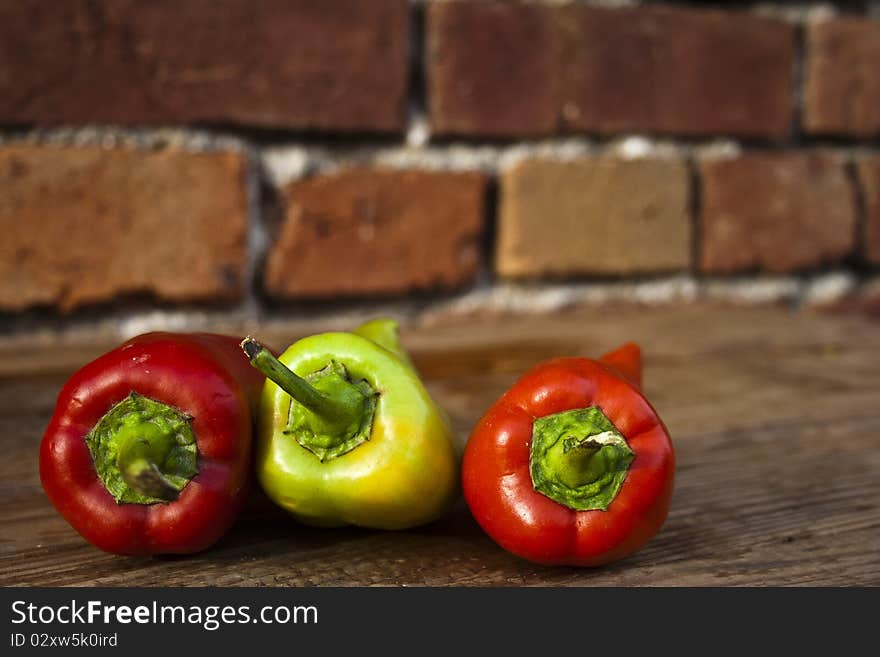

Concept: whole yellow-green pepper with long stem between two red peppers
[[242, 319, 459, 529]]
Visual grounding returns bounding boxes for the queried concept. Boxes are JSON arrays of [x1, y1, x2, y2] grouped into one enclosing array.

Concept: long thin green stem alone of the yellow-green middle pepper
[[241, 336, 364, 434]]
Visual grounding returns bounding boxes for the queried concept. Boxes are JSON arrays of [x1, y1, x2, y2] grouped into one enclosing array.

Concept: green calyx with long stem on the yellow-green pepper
[[241, 336, 376, 461]]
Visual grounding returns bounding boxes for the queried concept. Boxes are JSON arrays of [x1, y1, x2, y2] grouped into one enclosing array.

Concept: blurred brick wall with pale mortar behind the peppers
[[0, 0, 880, 330]]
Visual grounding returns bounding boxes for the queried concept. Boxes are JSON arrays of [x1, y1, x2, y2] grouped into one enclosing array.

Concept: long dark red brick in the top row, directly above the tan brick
[[427, 2, 794, 139]]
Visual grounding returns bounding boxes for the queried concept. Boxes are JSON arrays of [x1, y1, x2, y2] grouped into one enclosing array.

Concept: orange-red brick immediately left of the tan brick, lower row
[[265, 169, 486, 297]]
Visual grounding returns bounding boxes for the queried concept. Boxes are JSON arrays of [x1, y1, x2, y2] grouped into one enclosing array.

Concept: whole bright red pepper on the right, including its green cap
[[462, 343, 675, 566]]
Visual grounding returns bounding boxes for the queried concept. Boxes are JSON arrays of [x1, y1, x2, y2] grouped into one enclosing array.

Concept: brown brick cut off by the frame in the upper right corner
[[804, 18, 880, 137]]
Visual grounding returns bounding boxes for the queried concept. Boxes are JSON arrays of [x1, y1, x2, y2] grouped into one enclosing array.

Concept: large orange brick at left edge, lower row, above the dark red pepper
[[0, 145, 247, 311]]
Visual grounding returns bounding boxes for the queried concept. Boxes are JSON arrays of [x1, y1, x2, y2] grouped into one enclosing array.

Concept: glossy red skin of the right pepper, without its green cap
[[462, 343, 675, 566]]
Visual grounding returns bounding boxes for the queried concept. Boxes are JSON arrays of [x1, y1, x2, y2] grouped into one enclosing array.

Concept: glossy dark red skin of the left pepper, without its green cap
[[40, 333, 264, 555]]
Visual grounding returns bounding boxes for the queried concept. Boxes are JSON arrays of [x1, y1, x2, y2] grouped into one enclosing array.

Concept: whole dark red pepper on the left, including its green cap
[[40, 333, 264, 554]]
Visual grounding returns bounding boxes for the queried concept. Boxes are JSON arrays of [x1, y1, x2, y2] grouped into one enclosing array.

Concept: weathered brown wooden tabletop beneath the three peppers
[[0, 306, 880, 586]]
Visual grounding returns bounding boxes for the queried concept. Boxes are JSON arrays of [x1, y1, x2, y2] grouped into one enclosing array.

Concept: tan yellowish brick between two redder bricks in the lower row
[[496, 157, 690, 278]]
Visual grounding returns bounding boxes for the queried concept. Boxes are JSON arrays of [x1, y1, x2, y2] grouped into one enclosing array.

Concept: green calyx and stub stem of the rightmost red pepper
[[529, 406, 635, 511]]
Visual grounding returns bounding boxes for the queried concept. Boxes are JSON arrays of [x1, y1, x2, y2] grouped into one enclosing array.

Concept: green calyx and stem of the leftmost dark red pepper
[[85, 392, 198, 504]]
